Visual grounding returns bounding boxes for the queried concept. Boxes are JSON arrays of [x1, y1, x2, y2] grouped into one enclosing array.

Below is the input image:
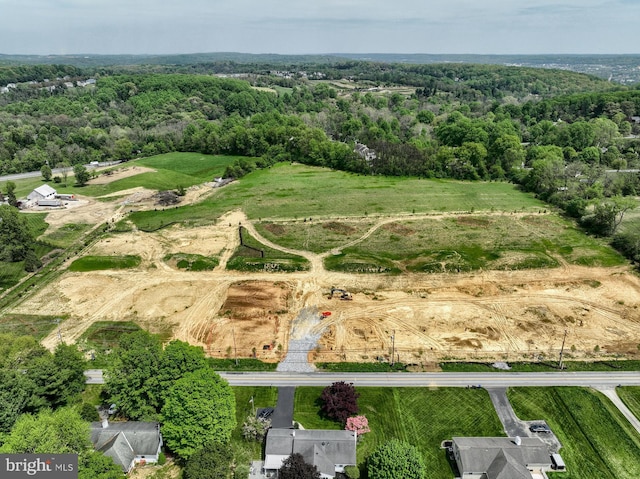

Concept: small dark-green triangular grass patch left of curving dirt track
[[227, 230, 309, 273]]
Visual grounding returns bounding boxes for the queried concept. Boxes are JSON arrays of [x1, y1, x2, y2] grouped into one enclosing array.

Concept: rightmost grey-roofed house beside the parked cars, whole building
[[451, 437, 552, 479]]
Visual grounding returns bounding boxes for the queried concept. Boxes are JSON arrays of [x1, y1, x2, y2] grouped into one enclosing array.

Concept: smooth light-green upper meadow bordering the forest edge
[[130, 163, 547, 230]]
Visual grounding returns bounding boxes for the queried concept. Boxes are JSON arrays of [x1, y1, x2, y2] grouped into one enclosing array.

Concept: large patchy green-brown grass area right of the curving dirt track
[[325, 215, 625, 273]]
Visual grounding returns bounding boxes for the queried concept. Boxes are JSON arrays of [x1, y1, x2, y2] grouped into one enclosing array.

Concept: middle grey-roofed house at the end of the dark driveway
[[264, 428, 357, 478]]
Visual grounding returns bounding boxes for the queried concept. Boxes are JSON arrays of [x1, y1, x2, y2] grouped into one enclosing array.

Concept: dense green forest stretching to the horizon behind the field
[[0, 59, 640, 258]]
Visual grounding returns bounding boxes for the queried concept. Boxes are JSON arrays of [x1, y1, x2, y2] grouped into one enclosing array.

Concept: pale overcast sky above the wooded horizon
[[0, 0, 640, 55]]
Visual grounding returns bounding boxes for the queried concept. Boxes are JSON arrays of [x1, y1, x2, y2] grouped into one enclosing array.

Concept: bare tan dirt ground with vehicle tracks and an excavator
[[14, 202, 640, 364]]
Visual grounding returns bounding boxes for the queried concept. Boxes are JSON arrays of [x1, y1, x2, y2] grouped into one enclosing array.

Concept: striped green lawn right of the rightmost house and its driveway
[[508, 387, 640, 479]]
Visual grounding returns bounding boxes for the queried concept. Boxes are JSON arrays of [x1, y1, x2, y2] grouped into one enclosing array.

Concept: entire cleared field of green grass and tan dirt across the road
[[2, 154, 640, 369]]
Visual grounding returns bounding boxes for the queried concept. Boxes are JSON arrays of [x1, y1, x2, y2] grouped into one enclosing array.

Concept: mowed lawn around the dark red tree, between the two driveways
[[294, 387, 504, 478]]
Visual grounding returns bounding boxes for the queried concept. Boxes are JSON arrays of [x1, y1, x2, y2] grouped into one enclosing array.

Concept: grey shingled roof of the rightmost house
[[453, 437, 551, 479]]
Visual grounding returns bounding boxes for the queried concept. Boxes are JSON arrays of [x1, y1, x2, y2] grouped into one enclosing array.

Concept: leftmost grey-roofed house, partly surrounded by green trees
[[91, 419, 162, 474]]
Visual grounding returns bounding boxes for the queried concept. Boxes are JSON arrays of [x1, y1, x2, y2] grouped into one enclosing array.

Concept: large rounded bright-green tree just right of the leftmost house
[[162, 369, 236, 459]]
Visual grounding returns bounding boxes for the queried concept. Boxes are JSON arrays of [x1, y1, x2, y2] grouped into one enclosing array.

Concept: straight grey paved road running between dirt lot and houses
[[85, 369, 640, 388]]
